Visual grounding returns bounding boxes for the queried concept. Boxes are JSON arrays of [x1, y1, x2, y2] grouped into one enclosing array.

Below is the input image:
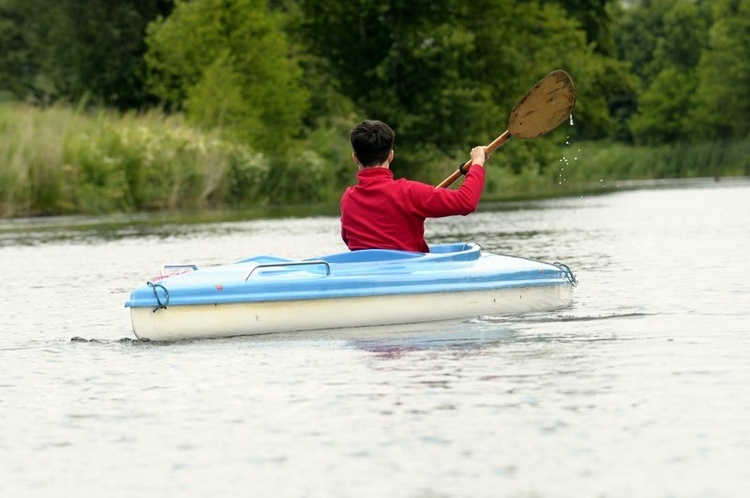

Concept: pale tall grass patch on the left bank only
[[0, 104, 269, 217]]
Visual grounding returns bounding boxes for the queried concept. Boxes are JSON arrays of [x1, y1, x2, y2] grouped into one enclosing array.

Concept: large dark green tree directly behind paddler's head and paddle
[[299, 0, 624, 169]]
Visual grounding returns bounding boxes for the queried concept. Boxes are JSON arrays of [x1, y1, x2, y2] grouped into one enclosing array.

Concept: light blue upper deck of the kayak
[[125, 243, 574, 307]]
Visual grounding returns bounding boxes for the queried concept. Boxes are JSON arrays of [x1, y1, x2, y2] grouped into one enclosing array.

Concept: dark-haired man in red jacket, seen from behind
[[341, 120, 494, 252]]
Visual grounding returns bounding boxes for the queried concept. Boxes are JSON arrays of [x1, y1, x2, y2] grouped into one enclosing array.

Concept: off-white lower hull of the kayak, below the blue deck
[[131, 285, 573, 341]]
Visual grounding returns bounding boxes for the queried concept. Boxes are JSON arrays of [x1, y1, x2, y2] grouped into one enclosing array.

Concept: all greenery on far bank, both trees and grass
[[0, 0, 750, 217]]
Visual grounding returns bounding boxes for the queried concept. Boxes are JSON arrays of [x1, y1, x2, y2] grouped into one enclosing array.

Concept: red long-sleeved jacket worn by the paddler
[[341, 165, 485, 252]]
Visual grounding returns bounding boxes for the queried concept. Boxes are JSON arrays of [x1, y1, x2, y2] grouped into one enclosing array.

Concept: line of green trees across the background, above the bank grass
[[0, 0, 750, 216]]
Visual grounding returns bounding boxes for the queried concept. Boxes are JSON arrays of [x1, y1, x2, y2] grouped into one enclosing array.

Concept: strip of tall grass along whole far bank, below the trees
[[0, 103, 750, 217]]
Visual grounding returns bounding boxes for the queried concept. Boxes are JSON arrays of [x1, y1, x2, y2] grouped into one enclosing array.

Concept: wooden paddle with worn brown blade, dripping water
[[437, 69, 576, 188]]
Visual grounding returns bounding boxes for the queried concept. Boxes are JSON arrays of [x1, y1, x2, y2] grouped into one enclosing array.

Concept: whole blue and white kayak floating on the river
[[125, 243, 576, 341]]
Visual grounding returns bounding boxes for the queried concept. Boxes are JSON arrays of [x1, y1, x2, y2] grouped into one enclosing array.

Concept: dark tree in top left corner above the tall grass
[[0, 0, 172, 109]]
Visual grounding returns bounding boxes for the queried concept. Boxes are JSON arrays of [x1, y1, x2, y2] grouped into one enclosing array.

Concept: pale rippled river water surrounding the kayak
[[0, 180, 750, 498]]
